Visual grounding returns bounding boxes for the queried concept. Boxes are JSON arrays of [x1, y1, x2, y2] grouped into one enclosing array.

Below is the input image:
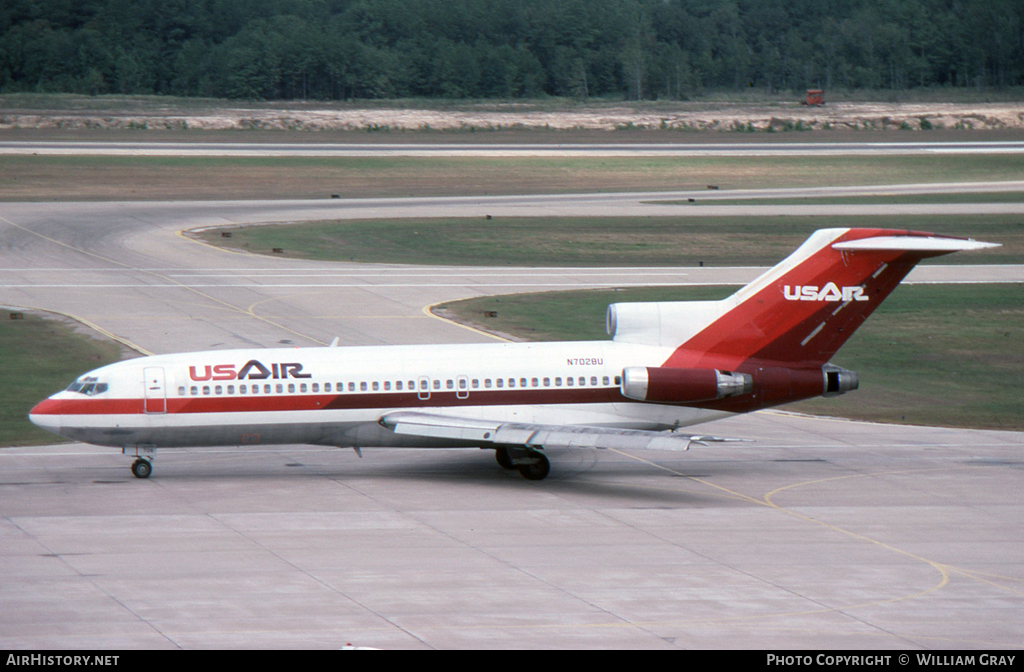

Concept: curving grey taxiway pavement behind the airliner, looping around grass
[[0, 187, 1024, 352]]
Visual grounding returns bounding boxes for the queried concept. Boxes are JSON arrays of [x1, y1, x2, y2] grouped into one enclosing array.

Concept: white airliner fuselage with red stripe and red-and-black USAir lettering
[[32, 341, 727, 448]]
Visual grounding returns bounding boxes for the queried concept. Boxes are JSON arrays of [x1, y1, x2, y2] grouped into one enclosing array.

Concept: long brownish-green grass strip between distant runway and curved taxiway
[[0, 155, 1024, 201]]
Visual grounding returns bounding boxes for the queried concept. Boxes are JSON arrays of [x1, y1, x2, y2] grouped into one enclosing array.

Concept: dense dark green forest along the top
[[0, 0, 1024, 99]]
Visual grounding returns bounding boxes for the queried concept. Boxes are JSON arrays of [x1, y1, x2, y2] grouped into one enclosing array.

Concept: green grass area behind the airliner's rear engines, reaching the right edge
[[437, 284, 1024, 430]]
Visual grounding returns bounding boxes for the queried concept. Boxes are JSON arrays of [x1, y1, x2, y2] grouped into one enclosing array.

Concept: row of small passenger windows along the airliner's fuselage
[[178, 376, 622, 396]]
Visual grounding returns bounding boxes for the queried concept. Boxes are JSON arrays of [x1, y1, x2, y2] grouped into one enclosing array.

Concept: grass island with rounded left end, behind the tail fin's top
[[199, 215, 1024, 266]]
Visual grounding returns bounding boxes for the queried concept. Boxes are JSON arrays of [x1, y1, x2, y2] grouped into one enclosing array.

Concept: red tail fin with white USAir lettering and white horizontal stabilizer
[[664, 228, 993, 371]]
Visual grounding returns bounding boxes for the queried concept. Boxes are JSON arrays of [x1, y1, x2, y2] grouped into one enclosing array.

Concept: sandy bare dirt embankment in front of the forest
[[0, 102, 1024, 132]]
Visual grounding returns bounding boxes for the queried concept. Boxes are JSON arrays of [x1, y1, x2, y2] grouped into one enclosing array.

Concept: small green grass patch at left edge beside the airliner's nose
[[0, 310, 121, 446]]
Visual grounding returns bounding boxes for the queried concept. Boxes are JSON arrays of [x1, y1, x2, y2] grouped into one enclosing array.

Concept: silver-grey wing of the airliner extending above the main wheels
[[378, 412, 749, 451]]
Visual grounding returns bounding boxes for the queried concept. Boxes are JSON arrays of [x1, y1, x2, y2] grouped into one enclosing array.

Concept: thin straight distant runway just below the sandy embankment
[[6, 140, 1024, 158]]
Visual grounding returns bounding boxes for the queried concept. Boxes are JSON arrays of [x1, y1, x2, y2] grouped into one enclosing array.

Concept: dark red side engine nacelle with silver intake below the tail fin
[[622, 367, 754, 404]]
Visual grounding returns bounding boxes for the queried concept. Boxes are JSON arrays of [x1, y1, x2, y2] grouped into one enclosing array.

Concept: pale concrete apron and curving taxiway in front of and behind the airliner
[[0, 186, 1024, 649]]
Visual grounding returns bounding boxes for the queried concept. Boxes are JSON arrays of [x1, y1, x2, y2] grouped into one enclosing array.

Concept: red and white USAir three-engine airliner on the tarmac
[[30, 228, 995, 480]]
